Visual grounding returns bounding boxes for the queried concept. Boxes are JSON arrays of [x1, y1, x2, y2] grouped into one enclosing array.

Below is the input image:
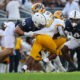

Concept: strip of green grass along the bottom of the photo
[[0, 72, 80, 80]]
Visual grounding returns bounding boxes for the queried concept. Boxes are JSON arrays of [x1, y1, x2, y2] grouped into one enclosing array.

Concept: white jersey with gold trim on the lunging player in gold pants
[[33, 19, 65, 37]]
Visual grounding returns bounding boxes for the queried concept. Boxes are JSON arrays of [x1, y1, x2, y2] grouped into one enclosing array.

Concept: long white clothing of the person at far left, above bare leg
[[5, 22, 15, 48]]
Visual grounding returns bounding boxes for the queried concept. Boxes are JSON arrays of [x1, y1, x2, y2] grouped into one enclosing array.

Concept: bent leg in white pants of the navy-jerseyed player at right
[[61, 39, 79, 68]]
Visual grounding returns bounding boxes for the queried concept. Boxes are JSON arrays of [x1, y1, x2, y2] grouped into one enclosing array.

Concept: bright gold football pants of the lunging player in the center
[[30, 35, 66, 60]]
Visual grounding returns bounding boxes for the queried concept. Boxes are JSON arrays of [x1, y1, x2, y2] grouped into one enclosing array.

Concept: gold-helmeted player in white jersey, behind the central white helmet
[[32, 3, 53, 27]]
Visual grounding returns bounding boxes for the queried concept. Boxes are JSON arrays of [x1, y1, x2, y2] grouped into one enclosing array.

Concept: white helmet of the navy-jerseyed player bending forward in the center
[[32, 13, 46, 27]]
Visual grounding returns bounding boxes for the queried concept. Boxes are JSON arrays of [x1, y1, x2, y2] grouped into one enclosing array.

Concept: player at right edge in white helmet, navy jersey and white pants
[[62, 10, 80, 68]]
